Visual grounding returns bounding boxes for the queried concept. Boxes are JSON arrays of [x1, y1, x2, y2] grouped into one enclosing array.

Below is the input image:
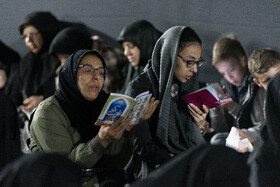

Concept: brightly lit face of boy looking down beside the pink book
[[215, 57, 247, 86]]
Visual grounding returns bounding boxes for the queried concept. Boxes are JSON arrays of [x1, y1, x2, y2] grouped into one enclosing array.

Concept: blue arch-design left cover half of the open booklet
[[95, 93, 135, 125]]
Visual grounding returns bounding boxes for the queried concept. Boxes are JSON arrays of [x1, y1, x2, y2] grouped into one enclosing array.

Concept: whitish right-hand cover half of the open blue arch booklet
[[128, 91, 152, 125]]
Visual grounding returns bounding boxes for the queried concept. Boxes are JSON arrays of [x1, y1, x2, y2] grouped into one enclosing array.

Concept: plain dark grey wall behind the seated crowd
[[0, 0, 280, 82]]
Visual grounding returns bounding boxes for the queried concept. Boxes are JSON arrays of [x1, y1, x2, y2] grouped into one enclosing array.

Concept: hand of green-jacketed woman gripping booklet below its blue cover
[[98, 117, 130, 148]]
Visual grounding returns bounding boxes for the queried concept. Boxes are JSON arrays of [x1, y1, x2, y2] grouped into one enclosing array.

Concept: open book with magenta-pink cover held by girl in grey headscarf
[[182, 83, 232, 108]]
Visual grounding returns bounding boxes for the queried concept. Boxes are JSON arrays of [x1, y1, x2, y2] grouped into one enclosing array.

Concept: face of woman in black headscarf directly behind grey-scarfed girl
[[122, 42, 140, 66]]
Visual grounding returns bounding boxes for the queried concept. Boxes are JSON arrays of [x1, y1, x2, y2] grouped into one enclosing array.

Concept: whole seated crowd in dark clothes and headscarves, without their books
[[0, 11, 280, 187]]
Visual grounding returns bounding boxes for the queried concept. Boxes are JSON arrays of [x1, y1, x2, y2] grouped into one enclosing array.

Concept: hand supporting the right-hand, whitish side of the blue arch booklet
[[126, 97, 159, 131]]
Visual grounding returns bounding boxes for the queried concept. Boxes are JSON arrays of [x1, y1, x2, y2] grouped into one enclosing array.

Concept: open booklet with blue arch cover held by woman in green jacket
[[95, 91, 152, 126]]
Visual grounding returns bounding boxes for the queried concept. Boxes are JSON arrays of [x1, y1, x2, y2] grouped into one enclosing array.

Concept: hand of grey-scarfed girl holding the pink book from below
[[188, 103, 209, 129]]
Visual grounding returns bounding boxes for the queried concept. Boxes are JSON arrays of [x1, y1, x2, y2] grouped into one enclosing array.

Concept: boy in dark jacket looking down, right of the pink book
[[210, 37, 265, 148]]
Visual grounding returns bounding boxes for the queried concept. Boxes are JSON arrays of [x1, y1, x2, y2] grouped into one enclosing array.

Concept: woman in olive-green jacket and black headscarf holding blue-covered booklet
[[29, 50, 158, 186]]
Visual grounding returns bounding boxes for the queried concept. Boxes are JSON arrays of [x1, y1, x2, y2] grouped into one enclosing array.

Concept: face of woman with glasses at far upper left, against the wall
[[22, 25, 43, 54]]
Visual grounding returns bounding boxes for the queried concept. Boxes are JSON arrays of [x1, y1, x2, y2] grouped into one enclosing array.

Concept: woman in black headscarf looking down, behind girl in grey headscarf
[[118, 20, 162, 93]]
